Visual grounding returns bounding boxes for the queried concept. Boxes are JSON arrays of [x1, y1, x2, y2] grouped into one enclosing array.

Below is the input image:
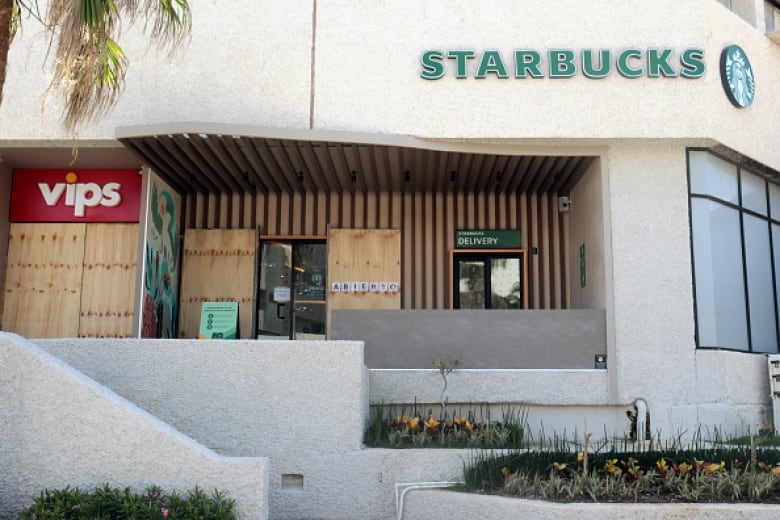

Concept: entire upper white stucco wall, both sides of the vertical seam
[[0, 0, 780, 169]]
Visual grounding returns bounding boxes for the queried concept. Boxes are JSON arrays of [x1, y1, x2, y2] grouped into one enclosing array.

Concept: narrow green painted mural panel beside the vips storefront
[[141, 177, 181, 338]]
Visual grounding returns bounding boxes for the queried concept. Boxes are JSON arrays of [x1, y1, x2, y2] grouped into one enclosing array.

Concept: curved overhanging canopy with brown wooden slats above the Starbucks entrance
[[117, 123, 593, 198]]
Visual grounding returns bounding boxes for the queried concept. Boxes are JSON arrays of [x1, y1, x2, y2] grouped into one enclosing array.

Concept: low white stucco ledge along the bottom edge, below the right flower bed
[[401, 489, 780, 520]]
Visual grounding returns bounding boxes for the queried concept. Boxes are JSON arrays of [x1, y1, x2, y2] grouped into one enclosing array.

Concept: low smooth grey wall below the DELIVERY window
[[331, 308, 606, 369]]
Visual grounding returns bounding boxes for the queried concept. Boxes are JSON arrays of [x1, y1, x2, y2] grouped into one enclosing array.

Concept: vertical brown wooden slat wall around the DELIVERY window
[[188, 188, 569, 309]]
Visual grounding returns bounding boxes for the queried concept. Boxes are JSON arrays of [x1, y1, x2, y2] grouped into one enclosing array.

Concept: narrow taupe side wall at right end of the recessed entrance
[[568, 160, 609, 309]]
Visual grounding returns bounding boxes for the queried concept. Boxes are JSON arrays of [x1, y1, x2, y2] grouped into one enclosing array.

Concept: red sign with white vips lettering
[[11, 170, 141, 222]]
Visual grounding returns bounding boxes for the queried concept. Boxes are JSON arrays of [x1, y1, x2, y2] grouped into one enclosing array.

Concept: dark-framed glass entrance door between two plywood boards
[[257, 240, 328, 339]]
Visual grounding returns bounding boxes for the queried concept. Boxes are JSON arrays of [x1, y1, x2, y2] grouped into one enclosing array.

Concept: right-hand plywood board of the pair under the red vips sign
[[79, 224, 138, 338]]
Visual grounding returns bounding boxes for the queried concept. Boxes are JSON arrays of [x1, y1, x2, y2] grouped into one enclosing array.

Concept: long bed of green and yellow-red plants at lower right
[[463, 440, 780, 503]]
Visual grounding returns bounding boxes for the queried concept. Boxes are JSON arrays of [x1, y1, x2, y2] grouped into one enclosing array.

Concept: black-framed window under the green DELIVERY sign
[[453, 251, 528, 309]]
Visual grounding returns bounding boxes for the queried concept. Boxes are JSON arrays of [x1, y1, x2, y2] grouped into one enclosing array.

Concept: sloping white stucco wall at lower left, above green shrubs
[[0, 333, 268, 519]]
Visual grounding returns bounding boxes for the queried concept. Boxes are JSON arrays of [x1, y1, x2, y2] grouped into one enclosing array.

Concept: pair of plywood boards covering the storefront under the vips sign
[[3, 223, 138, 338]]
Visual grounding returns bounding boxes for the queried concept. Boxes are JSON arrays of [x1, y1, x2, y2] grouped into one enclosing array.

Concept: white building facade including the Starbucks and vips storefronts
[[0, 0, 780, 433]]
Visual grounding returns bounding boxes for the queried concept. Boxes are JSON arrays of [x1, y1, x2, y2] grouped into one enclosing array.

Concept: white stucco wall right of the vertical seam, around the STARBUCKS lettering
[[315, 0, 780, 165]]
